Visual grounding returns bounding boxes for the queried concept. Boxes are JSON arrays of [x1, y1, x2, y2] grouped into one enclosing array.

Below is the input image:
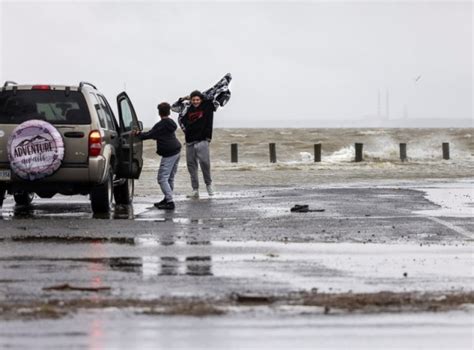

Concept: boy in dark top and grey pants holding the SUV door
[[136, 102, 181, 210]]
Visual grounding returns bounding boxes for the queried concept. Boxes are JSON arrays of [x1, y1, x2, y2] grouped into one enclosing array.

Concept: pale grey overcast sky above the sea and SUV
[[0, 1, 474, 127]]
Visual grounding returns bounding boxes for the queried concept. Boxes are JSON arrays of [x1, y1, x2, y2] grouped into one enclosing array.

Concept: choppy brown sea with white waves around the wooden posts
[[135, 128, 474, 188]]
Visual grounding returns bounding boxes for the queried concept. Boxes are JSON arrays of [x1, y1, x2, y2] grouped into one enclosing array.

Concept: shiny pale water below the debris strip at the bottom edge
[[0, 310, 473, 350]]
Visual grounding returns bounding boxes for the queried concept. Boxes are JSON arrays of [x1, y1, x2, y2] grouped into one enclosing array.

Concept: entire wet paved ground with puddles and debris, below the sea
[[0, 179, 474, 349]]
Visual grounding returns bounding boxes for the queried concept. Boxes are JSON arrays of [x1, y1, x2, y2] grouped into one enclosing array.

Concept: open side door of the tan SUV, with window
[[117, 92, 143, 179]]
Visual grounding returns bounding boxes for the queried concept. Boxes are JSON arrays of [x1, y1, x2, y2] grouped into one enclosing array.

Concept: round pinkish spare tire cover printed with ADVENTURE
[[8, 120, 64, 180]]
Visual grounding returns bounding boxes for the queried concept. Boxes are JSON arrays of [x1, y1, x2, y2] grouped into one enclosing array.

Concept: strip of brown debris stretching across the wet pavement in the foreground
[[0, 290, 474, 320]]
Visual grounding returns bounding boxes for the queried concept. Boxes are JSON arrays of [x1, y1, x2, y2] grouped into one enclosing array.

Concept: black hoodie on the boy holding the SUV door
[[138, 118, 181, 157]]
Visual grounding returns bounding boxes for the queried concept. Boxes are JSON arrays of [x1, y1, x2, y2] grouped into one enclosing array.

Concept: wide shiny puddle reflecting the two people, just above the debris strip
[[0, 235, 474, 299]]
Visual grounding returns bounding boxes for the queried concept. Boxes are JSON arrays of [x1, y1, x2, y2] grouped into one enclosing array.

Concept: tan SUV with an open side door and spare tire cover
[[0, 82, 143, 213]]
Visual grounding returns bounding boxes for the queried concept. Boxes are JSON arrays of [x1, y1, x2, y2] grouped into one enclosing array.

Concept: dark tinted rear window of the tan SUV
[[0, 90, 91, 124]]
